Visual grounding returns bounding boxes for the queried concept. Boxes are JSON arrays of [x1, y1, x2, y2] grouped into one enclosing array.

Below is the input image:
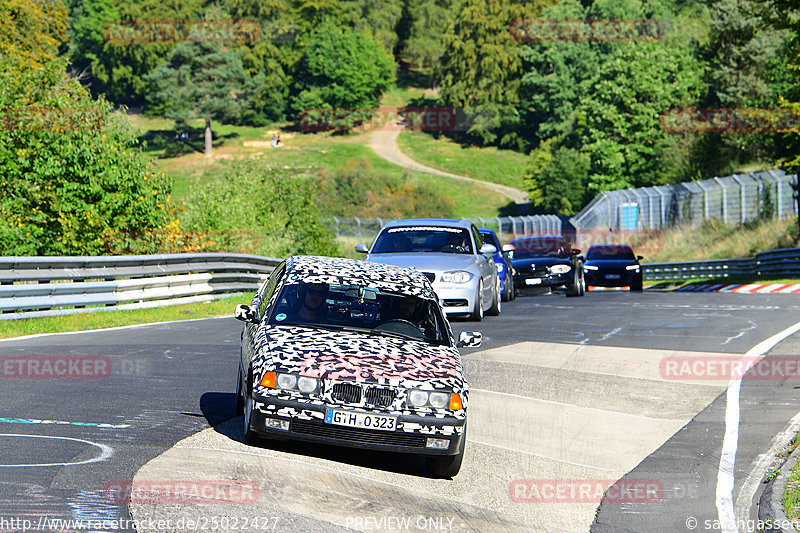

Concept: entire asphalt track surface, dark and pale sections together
[[0, 292, 800, 532]]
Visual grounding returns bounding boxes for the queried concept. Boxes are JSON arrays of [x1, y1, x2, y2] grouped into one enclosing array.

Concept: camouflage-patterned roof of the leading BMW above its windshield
[[286, 255, 436, 299]]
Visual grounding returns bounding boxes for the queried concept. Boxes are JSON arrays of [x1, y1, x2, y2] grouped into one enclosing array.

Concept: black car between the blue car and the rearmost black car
[[504, 235, 586, 296]]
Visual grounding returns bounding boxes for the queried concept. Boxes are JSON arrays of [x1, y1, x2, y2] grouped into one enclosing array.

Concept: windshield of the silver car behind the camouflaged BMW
[[372, 226, 473, 254]]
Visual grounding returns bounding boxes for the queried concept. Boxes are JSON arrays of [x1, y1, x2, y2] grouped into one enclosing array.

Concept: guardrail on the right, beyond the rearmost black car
[[642, 248, 800, 281]]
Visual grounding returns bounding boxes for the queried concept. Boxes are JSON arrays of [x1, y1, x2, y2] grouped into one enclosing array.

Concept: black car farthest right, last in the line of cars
[[583, 244, 642, 291]]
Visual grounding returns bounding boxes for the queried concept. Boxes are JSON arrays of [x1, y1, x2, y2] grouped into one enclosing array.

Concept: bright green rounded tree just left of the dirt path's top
[[292, 22, 394, 120]]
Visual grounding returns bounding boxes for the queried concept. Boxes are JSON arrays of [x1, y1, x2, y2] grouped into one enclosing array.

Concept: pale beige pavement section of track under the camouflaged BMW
[[129, 342, 739, 533]]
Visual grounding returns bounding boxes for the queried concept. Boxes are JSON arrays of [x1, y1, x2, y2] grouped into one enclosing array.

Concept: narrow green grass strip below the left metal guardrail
[[0, 294, 253, 338]]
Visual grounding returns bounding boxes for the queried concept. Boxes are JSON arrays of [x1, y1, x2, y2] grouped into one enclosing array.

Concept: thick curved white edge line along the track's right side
[[716, 322, 800, 533]]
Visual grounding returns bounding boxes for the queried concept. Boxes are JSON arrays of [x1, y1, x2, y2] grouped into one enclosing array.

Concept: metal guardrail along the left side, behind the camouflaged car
[[0, 253, 281, 320]]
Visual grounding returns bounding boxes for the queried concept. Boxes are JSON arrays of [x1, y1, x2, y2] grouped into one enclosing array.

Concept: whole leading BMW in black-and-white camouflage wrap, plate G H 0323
[[231, 256, 481, 477]]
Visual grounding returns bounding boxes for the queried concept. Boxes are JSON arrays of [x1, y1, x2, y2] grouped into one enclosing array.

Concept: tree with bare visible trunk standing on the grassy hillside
[[145, 42, 265, 156]]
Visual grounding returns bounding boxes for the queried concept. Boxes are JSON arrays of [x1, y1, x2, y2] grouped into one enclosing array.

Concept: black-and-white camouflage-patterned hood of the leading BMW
[[266, 326, 463, 387]]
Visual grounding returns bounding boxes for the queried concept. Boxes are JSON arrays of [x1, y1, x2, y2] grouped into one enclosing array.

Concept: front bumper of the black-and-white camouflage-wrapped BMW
[[251, 395, 465, 455]]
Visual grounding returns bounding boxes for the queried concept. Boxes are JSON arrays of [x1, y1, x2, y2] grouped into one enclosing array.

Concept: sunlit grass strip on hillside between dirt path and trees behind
[[397, 131, 528, 189]]
